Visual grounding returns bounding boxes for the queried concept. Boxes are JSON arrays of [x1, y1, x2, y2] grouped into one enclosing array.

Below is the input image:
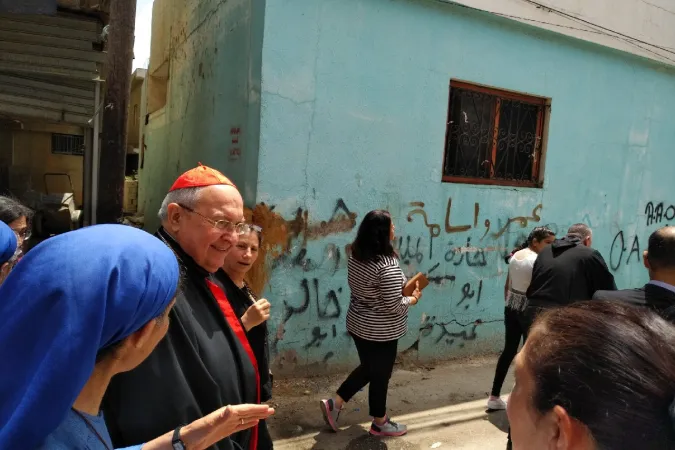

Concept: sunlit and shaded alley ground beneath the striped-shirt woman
[[270, 358, 513, 450]]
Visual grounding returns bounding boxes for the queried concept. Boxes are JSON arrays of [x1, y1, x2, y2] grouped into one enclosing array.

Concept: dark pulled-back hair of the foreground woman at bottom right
[[523, 301, 675, 450]]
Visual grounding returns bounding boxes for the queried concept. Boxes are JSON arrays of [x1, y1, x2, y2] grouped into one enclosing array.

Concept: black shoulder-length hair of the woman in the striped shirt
[[352, 209, 398, 262]]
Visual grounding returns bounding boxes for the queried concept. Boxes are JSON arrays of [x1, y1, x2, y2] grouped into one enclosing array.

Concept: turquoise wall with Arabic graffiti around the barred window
[[257, 0, 675, 371]]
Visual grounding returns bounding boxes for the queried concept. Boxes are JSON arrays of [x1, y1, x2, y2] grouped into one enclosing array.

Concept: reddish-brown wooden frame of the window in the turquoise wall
[[441, 80, 551, 188]]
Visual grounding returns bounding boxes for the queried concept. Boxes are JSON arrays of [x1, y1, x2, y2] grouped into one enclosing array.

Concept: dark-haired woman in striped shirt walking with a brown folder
[[321, 210, 422, 436]]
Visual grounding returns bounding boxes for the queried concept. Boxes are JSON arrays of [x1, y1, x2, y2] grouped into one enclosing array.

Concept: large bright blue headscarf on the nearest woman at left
[[0, 225, 179, 449]]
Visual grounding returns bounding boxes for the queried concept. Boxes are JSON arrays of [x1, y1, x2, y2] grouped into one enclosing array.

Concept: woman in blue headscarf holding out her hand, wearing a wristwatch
[[0, 225, 273, 450]]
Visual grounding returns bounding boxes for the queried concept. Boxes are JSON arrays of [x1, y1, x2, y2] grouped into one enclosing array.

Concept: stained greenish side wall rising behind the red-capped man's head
[[139, 0, 264, 229]]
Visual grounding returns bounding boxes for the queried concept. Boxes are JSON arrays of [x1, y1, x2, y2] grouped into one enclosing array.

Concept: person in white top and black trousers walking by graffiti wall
[[487, 227, 555, 410]]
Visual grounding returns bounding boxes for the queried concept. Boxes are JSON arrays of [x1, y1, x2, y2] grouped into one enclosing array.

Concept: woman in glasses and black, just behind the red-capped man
[[216, 225, 273, 450]]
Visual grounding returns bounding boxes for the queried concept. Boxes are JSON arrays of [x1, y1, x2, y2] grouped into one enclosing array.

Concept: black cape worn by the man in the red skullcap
[[103, 229, 258, 450]]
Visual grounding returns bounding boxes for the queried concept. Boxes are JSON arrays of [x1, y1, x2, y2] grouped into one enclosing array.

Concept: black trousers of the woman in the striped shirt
[[337, 335, 398, 417]]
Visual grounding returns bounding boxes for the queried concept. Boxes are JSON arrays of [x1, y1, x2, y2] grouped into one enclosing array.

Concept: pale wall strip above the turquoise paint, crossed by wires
[[448, 0, 675, 65]]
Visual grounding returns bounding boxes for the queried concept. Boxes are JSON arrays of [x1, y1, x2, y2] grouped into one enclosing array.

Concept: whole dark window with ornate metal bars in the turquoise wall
[[443, 80, 549, 187]]
